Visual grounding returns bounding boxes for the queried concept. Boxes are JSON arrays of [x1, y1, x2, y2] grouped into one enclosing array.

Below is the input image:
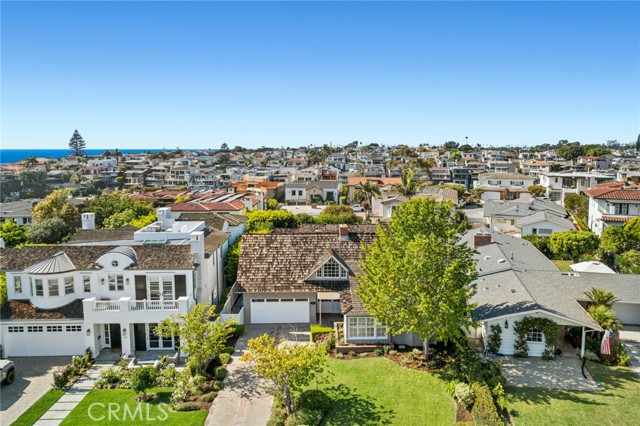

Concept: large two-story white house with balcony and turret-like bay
[[0, 208, 228, 356]]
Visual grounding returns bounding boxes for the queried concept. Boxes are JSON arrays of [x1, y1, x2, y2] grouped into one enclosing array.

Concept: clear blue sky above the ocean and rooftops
[[0, 1, 640, 148]]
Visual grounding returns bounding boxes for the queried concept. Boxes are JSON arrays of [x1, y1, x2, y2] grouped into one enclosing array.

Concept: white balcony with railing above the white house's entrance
[[82, 297, 192, 323]]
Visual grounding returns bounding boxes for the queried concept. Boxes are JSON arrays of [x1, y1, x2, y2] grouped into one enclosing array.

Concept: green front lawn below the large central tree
[[319, 358, 456, 426]]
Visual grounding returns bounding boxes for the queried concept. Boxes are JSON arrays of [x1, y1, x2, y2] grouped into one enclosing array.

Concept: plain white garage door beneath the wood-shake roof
[[251, 298, 309, 324]]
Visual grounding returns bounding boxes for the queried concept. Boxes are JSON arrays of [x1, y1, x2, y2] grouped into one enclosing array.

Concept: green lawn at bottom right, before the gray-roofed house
[[507, 362, 640, 426]]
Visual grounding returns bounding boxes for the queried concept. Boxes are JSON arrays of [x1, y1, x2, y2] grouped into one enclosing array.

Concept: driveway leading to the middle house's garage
[[205, 324, 309, 426]]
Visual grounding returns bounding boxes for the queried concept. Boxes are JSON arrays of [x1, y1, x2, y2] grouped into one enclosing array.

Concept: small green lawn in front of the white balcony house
[[61, 388, 207, 426]]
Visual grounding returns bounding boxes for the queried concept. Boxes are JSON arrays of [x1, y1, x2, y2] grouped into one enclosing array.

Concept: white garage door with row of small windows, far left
[[2, 324, 85, 357]]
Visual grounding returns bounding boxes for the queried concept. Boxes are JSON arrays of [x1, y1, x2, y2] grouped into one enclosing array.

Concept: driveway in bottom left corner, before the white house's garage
[[0, 356, 71, 425]]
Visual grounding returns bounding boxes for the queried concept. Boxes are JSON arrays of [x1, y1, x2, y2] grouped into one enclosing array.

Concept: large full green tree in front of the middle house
[[356, 198, 477, 360]]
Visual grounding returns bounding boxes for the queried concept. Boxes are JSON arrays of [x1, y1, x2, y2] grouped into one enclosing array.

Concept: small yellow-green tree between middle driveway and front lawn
[[241, 334, 327, 414]]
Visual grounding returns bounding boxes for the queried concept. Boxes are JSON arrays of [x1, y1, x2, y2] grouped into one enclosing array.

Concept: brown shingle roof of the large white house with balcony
[[0, 245, 195, 271]]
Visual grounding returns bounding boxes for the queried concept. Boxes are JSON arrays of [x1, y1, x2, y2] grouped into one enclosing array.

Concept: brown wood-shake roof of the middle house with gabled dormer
[[237, 225, 376, 298]]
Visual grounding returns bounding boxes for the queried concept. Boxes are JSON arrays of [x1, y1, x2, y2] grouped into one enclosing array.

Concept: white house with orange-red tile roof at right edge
[[584, 182, 640, 235]]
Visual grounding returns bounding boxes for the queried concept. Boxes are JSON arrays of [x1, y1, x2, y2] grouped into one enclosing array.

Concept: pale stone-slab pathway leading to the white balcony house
[[34, 357, 114, 426]]
